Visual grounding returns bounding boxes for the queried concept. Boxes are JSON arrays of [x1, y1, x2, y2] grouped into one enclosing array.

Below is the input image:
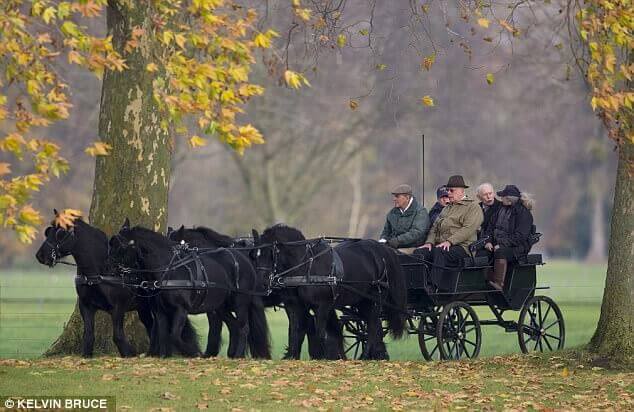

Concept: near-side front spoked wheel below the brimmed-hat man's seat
[[436, 302, 482, 360]]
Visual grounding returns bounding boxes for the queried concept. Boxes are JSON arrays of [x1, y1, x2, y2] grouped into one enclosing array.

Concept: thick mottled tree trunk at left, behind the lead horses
[[46, 1, 172, 355]]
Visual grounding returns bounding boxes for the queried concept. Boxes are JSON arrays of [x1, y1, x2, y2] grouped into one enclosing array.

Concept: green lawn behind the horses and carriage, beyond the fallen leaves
[[0, 261, 605, 360]]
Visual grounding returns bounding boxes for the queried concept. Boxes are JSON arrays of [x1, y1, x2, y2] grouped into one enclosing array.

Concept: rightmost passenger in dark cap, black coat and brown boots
[[484, 185, 533, 290]]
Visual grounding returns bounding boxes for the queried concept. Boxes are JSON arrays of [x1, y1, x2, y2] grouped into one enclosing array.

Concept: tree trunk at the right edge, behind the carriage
[[590, 142, 634, 360]]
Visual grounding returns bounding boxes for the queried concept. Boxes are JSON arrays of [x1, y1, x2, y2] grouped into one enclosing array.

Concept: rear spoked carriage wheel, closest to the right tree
[[517, 296, 566, 353]]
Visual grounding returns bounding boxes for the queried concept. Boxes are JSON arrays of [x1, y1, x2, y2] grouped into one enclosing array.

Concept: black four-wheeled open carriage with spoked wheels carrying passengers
[[340, 248, 565, 360]]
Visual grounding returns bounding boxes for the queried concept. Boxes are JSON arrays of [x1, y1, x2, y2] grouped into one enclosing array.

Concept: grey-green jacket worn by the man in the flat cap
[[381, 197, 429, 248]]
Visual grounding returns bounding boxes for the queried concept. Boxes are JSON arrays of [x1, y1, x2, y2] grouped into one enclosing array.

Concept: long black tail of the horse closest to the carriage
[[379, 246, 407, 339]]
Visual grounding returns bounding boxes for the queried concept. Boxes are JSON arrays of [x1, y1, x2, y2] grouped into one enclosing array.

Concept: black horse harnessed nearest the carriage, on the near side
[[254, 225, 407, 359]]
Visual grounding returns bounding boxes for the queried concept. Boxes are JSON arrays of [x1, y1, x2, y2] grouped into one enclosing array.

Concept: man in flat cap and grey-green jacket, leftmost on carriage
[[379, 184, 429, 249]]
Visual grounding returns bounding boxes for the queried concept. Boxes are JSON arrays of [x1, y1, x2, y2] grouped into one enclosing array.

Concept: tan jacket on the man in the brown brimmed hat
[[426, 197, 484, 253]]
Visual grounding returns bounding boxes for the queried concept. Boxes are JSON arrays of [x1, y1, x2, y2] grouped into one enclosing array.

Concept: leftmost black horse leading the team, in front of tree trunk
[[35, 210, 197, 357]]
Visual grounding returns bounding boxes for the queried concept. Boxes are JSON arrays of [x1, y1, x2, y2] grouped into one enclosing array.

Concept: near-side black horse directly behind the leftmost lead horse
[[110, 220, 271, 359]]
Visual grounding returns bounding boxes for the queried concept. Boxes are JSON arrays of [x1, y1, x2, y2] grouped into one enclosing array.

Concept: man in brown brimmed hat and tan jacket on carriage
[[414, 175, 484, 285]]
